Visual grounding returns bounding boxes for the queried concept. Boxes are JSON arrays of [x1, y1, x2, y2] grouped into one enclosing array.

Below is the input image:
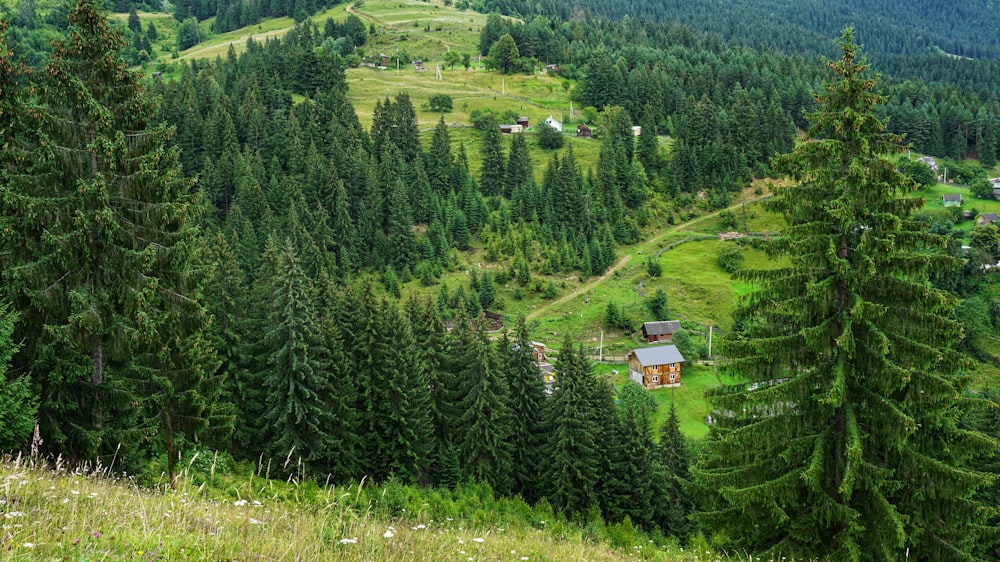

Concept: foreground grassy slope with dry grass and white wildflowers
[[0, 459, 760, 562]]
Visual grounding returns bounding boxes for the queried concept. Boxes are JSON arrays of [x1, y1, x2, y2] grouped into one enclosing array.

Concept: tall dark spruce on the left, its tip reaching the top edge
[[2, 0, 195, 459]]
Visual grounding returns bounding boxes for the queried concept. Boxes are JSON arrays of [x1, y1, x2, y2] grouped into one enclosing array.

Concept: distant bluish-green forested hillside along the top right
[[483, 0, 1000, 92]]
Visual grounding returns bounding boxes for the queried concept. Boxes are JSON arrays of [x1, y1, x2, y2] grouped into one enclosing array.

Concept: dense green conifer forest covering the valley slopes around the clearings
[[0, 0, 1000, 560]]
